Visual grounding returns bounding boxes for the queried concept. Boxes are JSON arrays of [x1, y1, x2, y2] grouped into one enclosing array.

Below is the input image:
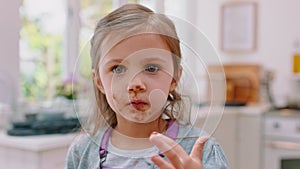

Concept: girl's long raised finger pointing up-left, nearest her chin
[[150, 133, 190, 168]]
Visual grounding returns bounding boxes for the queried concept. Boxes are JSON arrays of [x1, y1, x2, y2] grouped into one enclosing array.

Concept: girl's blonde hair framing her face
[[87, 4, 188, 134]]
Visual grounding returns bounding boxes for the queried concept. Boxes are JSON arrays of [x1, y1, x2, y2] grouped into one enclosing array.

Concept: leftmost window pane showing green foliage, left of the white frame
[[20, 0, 66, 100]]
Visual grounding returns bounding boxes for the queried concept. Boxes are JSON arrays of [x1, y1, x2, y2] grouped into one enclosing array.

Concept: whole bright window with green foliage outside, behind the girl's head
[[20, 0, 169, 101]]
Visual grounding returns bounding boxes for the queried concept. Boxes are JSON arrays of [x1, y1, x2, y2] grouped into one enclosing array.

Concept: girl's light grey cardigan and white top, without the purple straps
[[65, 125, 229, 169]]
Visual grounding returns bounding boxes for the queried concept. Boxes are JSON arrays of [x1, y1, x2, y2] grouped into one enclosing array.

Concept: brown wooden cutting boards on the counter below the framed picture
[[209, 64, 261, 105]]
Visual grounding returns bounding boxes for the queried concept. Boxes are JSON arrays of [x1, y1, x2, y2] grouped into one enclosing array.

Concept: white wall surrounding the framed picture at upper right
[[195, 0, 300, 105]]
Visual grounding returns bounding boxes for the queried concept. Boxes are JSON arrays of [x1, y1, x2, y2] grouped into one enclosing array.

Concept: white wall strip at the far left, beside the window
[[0, 0, 21, 105]]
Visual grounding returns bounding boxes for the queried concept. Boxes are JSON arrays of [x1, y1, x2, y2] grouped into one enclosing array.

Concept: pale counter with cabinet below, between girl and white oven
[[191, 104, 270, 169]]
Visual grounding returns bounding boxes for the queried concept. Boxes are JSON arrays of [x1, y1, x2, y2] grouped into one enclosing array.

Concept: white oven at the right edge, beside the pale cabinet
[[263, 109, 300, 169]]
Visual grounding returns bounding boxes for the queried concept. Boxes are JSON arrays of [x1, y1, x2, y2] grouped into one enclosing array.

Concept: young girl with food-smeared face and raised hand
[[66, 4, 228, 169]]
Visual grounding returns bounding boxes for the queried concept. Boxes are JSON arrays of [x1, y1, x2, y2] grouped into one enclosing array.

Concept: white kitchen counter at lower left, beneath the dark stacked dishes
[[0, 131, 76, 169]]
